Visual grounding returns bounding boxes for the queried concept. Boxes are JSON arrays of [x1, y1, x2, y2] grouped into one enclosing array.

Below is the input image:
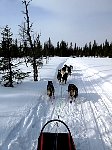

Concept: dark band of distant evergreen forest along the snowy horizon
[[0, 38, 112, 58]]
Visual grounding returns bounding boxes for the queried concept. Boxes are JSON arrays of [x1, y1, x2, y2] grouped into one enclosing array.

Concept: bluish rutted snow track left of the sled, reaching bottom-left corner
[[2, 97, 54, 150]]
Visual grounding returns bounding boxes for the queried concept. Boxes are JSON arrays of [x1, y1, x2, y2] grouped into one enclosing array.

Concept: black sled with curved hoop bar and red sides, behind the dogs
[[37, 119, 76, 150]]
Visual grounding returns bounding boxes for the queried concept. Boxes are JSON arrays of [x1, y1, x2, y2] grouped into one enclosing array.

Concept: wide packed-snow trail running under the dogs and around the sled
[[0, 58, 112, 150]]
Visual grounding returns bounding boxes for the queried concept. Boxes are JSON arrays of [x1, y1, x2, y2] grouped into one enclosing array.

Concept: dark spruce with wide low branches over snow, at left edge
[[0, 25, 29, 87]]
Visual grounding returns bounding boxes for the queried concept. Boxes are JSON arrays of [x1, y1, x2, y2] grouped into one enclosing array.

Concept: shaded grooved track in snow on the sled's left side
[[1, 96, 47, 150]]
